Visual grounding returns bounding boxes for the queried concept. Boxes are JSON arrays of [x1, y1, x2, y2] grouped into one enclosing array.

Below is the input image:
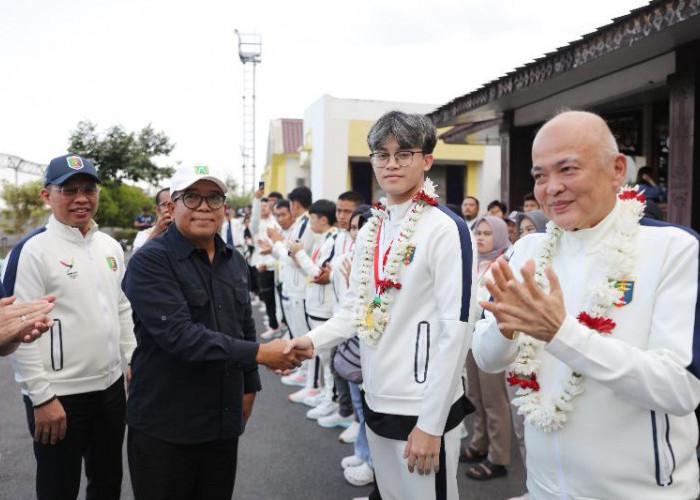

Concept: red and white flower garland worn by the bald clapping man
[[507, 186, 645, 432]]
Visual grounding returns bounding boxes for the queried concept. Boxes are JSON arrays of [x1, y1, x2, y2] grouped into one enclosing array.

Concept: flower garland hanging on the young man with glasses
[[355, 178, 438, 345]]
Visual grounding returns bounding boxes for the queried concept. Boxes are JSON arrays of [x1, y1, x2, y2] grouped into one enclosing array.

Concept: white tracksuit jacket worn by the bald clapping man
[[472, 201, 700, 500]]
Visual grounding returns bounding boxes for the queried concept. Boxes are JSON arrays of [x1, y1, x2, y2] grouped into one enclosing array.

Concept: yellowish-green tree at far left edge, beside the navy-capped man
[[0, 180, 49, 234]]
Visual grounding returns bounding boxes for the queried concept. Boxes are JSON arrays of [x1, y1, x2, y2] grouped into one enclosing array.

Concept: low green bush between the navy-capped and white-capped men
[[95, 182, 153, 228]]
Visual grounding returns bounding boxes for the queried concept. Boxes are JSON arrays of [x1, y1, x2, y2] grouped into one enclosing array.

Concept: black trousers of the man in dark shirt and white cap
[[127, 427, 238, 500]]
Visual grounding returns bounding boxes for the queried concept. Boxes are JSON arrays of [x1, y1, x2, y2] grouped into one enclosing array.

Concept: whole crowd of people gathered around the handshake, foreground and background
[[0, 111, 700, 500]]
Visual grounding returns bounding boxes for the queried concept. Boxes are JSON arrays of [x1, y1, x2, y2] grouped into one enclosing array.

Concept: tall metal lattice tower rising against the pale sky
[[235, 30, 262, 194]]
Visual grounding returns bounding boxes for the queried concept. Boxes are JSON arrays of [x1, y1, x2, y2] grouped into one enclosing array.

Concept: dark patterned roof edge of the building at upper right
[[428, 0, 700, 127]]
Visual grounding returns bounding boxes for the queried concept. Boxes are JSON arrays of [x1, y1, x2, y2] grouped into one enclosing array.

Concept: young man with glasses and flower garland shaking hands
[[289, 111, 475, 500]]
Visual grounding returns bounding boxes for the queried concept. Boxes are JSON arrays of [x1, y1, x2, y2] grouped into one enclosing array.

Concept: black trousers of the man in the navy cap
[[24, 377, 126, 500]]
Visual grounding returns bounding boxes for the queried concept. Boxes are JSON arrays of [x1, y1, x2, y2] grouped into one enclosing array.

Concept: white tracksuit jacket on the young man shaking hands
[[309, 202, 476, 435]]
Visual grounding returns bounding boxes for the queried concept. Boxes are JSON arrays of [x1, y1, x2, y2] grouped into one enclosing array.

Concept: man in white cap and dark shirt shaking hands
[[122, 165, 309, 500]]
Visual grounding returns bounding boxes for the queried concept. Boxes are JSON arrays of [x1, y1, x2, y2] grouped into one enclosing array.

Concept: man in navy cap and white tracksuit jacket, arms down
[[3, 154, 136, 500]]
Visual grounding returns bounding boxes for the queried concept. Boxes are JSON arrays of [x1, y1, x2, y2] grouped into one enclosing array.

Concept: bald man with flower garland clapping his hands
[[472, 111, 700, 499]]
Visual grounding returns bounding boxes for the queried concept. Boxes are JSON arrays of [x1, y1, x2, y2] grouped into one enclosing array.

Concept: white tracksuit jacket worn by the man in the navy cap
[[3, 216, 136, 405]]
